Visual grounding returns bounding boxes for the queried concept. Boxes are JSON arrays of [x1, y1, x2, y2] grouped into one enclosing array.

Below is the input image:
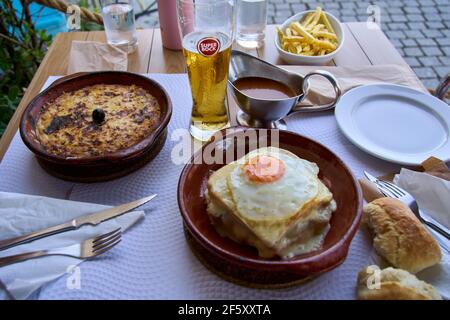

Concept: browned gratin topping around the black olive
[[36, 84, 161, 158]]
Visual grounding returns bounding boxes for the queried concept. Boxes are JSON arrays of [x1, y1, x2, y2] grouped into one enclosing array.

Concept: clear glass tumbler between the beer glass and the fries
[[236, 0, 267, 48]]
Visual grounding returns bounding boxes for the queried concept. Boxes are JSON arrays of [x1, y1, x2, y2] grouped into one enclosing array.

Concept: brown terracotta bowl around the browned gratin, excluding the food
[[20, 71, 172, 182]]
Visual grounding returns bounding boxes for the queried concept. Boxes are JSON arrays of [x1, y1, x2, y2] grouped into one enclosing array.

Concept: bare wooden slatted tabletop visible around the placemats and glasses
[[0, 22, 414, 160]]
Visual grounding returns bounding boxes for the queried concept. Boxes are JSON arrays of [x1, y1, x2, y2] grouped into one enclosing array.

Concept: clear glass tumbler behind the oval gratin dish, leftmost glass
[[100, 0, 137, 53]]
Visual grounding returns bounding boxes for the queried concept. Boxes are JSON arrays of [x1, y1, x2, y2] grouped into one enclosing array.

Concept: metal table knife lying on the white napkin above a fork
[[0, 194, 156, 251]]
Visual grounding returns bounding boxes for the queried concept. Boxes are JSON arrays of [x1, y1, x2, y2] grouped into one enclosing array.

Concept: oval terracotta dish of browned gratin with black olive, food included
[[20, 71, 172, 182]]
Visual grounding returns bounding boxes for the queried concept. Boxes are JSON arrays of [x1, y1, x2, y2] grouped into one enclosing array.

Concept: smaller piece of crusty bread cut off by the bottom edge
[[357, 266, 442, 300]]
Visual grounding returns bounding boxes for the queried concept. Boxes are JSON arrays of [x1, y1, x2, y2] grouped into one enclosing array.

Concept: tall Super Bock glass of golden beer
[[177, 0, 234, 141]]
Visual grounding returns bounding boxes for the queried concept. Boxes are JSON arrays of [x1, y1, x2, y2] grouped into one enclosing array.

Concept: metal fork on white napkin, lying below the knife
[[0, 228, 122, 267]]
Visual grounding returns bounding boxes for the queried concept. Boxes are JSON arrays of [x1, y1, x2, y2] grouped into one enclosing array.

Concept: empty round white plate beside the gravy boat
[[335, 84, 450, 165]]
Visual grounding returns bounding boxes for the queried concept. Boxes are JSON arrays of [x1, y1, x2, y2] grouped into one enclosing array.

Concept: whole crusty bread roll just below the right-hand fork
[[363, 198, 441, 273]]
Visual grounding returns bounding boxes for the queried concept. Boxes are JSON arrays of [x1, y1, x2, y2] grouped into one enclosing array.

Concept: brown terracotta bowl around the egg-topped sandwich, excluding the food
[[178, 127, 362, 288]]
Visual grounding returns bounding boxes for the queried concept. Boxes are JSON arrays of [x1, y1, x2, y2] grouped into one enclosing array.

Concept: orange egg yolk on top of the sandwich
[[244, 155, 286, 183]]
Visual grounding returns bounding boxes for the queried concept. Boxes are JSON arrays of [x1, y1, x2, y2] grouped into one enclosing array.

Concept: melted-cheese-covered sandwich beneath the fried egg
[[205, 148, 336, 259]]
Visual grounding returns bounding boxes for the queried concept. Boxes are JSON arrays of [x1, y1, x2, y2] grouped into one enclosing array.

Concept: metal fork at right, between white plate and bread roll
[[364, 171, 450, 240]]
